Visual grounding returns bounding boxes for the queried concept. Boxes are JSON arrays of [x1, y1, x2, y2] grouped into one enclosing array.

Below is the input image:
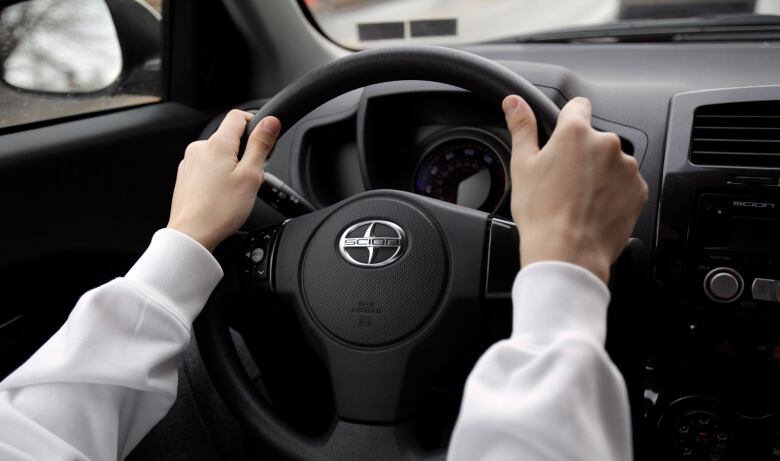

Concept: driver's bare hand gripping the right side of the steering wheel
[[503, 95, 647, 283]]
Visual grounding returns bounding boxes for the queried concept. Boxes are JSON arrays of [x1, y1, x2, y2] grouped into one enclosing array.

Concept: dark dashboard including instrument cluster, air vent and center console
[[262, 42, 780, 461]]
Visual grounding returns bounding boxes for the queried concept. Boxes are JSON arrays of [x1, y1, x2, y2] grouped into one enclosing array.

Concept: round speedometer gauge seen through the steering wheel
[[413, 129, 509, 212]]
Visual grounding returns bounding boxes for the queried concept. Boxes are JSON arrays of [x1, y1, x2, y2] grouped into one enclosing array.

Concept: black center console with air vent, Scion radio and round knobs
[[656, 86, 780, 461]]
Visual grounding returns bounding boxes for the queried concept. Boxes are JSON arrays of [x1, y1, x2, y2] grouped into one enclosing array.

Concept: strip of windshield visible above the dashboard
[[304, 0, 780, 49]]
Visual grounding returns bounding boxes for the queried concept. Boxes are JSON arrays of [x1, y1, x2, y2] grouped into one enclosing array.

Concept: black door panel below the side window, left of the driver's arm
[[0, 103, 212, 377]]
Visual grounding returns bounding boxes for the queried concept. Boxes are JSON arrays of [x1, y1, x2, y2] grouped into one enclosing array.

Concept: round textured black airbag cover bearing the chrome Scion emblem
[[301, 197, 449, 347]]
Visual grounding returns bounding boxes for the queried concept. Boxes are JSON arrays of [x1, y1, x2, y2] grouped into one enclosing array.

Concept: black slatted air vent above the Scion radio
[[691, 101, 780, 168]]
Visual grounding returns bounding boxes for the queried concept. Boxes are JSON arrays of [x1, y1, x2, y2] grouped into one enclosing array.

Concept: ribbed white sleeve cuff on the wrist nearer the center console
[[512, 261, 610, 346]]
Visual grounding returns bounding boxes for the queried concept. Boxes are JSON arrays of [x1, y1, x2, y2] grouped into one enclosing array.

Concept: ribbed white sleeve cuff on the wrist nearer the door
[[125, 229, 223, 330]]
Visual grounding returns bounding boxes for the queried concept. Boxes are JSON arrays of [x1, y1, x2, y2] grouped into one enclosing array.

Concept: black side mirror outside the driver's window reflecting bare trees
[[0, 0, 161, 96]]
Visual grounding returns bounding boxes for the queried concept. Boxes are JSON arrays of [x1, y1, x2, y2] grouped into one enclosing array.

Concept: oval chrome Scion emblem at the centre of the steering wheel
[[339, 221, 406, 267]]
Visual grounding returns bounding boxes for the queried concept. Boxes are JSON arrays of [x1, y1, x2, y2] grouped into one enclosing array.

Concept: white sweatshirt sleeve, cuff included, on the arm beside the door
[[0, 229, 222, 461]]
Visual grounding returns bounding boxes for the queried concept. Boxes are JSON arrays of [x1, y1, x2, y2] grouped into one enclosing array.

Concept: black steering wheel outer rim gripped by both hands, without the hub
[[195, 46, 559, 460]]
